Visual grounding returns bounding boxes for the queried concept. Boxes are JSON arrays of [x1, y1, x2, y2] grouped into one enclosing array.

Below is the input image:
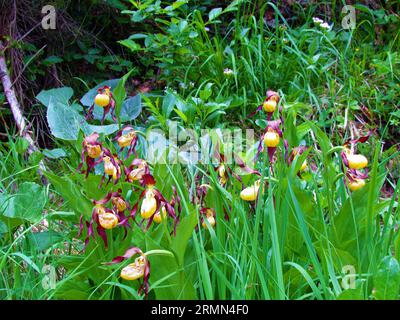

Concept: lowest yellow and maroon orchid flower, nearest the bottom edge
[[106, 247, 150, 298]]
